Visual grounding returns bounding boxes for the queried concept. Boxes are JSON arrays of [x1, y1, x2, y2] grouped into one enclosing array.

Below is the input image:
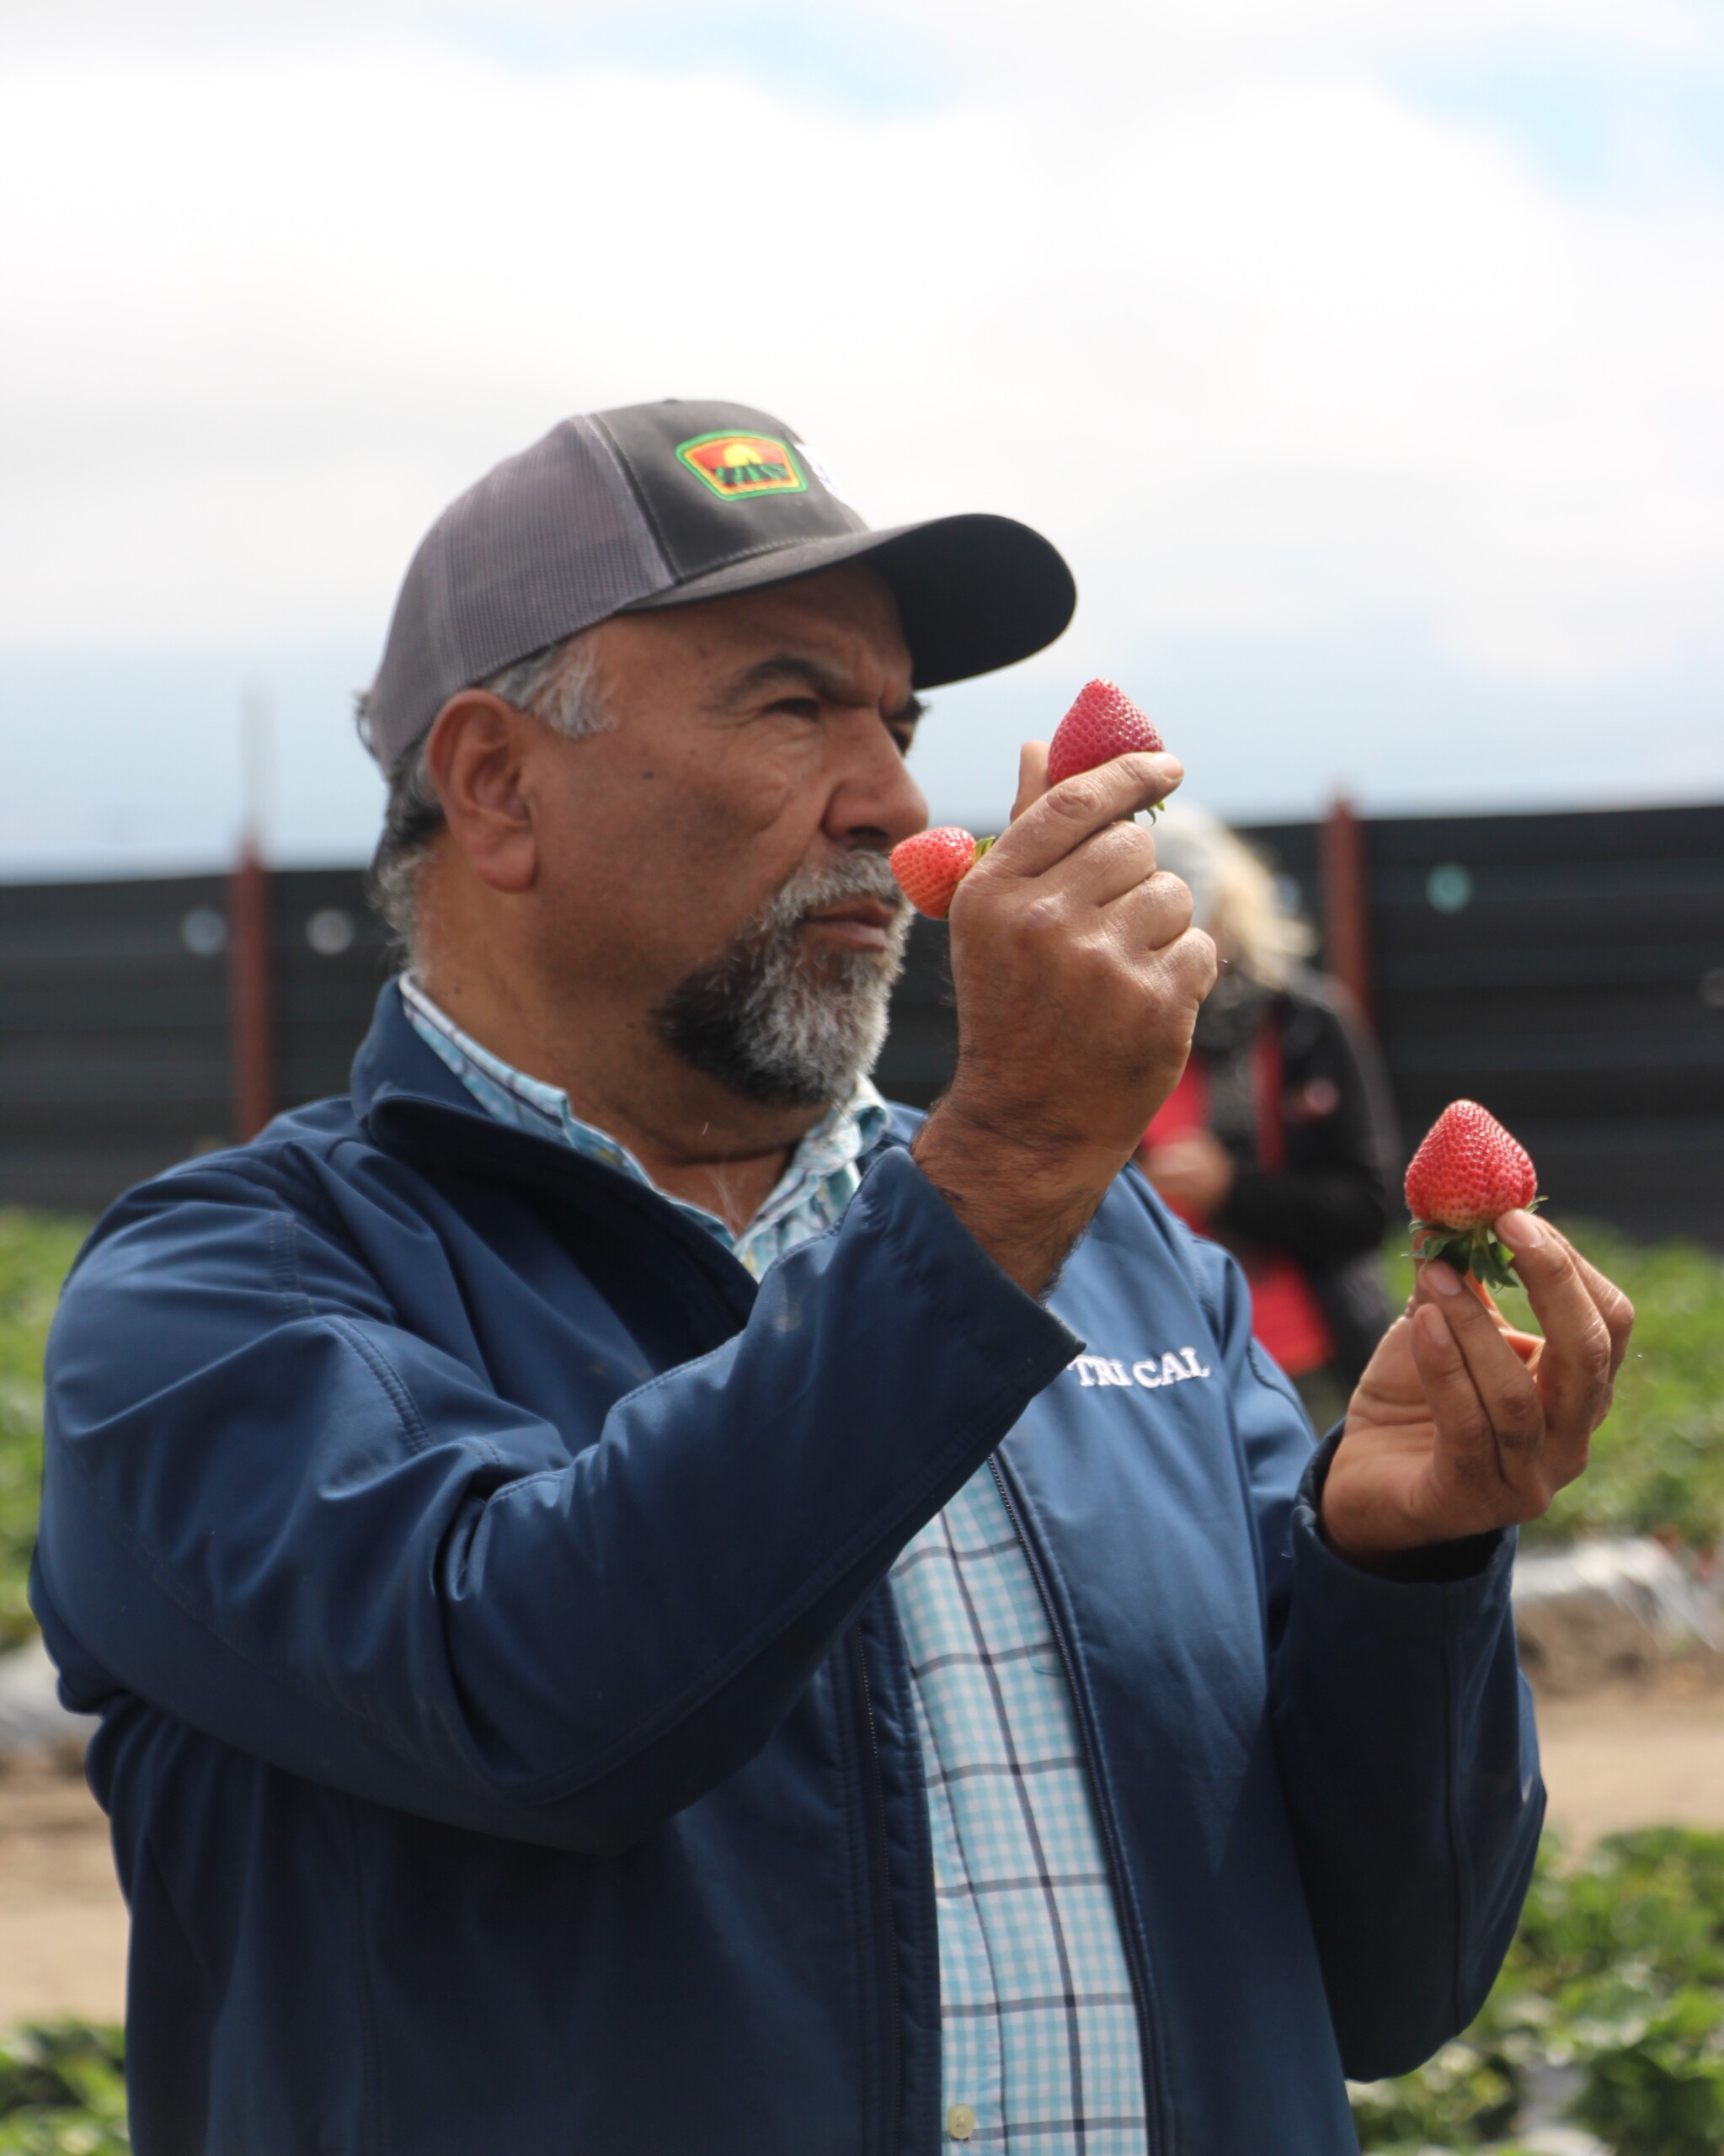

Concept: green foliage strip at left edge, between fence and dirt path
[[0, 1212, 84, 1646]]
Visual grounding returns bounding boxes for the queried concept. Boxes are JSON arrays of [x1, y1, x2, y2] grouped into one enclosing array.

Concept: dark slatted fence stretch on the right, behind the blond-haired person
[[1250, 808, 1724, 1246]]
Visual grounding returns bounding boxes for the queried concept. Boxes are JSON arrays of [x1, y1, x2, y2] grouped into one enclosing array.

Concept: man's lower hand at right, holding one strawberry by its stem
[[1321, 1212, 1634, 1572]]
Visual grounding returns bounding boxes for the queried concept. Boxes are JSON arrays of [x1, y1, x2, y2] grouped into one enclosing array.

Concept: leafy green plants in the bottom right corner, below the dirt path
[[1353, 1826, 1724, 2156]]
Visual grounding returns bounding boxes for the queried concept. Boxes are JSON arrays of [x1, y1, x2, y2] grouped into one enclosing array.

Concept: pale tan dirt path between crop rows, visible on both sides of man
[[0, 1684, 1724, 2026]]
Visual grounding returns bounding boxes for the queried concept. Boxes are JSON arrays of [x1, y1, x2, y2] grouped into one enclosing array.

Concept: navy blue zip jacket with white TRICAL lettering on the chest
[[35, 987, 1543, 2156]]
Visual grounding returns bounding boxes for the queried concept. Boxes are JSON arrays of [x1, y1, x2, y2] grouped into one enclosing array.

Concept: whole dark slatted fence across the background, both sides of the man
[[0, 806, 1724, 1246]]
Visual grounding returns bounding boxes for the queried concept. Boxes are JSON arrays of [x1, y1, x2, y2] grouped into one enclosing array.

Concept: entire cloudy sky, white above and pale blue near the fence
[[0, 0, 1724, 875]]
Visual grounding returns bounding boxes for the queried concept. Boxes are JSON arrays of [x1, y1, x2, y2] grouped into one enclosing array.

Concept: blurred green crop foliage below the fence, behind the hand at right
[[1388, 1220, 1724, 1548]]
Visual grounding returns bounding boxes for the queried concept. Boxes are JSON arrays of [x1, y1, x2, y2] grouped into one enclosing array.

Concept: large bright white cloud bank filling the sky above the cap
[[0, 0, 1724, 853]]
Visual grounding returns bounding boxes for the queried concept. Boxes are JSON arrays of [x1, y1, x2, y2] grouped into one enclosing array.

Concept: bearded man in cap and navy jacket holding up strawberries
[[35, 403, 1629, 2156]]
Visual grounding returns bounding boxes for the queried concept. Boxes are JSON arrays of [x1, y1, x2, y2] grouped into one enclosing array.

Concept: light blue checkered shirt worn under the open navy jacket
[[401, 979, 1149, 2156]]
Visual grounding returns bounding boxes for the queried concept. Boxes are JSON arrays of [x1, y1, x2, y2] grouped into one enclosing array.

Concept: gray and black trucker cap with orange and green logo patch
[[366, 399, 1077, 770]]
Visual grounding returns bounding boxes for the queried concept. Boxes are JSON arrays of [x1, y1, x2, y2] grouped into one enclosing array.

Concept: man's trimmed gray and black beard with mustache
[[653, 854, 910, 1108]]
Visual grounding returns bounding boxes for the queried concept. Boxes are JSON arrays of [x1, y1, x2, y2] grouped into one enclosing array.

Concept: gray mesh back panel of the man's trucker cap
[[369, 419, 672, 770]]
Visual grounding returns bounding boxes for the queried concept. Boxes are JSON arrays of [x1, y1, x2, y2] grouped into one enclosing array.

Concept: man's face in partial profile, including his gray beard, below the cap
[[532, 567, 926, 1106]]
